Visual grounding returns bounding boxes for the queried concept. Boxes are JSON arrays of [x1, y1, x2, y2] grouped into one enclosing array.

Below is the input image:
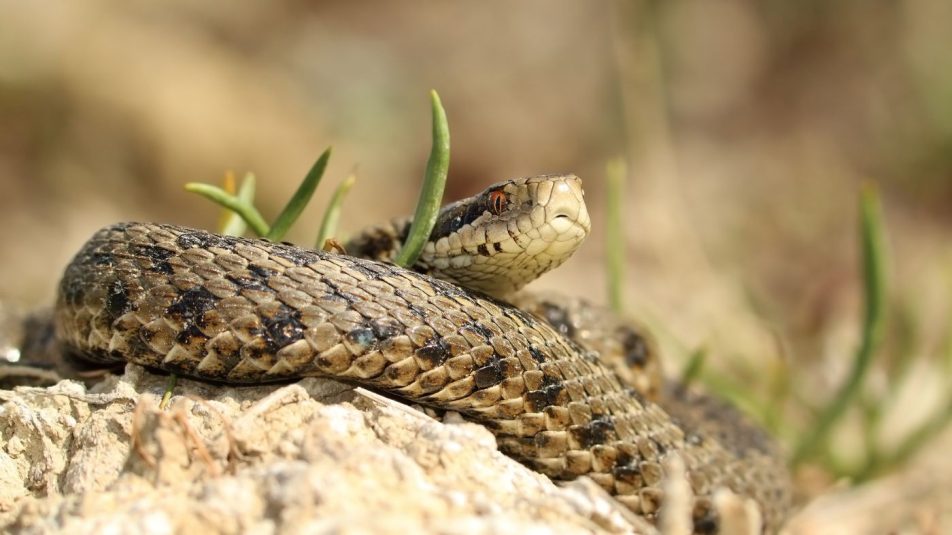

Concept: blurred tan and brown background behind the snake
[[0, 0, 952, 528]]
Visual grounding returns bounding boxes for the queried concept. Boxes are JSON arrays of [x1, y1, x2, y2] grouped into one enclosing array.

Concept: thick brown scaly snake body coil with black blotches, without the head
[[55, 223, 789, 532]]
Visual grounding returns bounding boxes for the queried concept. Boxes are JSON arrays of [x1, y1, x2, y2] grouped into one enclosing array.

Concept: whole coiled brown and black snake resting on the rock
[[54, 175, 790, 533]]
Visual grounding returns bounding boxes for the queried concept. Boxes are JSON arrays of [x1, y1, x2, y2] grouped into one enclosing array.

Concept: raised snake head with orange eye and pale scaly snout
[[417, 175, 591, 296]]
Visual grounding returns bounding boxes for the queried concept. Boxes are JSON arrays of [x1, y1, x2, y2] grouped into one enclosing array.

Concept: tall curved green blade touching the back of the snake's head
[[394, 91, 450, 267]]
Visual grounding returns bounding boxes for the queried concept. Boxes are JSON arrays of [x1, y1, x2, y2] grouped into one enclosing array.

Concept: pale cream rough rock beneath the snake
[[0, 365, 655, 535]]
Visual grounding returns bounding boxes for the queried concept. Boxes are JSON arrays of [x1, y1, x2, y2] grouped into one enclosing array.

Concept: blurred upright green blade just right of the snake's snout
[[605, 158, 627, 314]]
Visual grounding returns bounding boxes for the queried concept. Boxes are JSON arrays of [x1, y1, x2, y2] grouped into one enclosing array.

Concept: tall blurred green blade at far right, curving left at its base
[[793, 186, 886, 464]]
